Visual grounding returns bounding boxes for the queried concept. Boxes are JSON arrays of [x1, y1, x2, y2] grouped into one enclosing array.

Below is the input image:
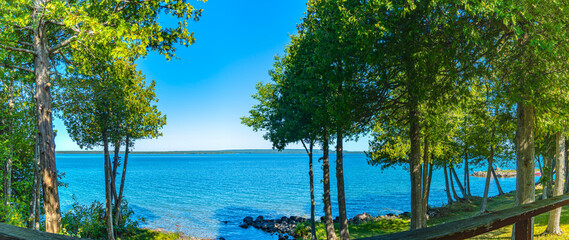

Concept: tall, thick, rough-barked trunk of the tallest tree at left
[[32, 0, 61, 233]]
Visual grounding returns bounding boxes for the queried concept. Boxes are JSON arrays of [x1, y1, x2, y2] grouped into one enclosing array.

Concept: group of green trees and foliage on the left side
[[0, 0, 202, 239]]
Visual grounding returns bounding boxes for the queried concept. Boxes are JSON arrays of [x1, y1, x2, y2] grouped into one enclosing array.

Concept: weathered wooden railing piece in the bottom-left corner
[[0, 223, 84, 240]]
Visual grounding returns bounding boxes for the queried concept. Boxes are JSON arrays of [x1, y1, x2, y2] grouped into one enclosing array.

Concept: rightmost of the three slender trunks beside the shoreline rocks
[[336, 131, 350, 240]]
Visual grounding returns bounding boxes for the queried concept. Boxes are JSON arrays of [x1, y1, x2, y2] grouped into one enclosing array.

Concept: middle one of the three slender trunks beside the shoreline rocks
[[322, 134, 336, 240]]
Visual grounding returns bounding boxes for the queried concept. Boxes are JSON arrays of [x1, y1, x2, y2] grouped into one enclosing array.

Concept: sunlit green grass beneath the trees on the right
[[297, 189, 569, 240]]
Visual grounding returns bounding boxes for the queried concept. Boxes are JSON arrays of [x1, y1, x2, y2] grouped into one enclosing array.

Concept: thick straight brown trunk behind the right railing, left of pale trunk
[[512, 102, 535, 238]]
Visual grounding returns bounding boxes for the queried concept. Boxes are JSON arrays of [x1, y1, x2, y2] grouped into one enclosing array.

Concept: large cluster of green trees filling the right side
[[242, 0, 569, 240]]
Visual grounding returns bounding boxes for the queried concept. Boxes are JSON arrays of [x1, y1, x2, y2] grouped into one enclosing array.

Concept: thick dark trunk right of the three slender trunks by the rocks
[[409, 99, 424, 230]]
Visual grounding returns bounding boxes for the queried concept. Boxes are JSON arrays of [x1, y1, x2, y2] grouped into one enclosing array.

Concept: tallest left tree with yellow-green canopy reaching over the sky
[[0, 0, 201, 232]]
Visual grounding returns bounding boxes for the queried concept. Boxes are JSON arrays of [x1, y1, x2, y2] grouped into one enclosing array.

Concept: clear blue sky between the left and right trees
[[54, 0, 368, 151]]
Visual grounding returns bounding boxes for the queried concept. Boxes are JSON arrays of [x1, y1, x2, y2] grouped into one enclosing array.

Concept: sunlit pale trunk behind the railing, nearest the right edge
[[545, 132, 565, 235]]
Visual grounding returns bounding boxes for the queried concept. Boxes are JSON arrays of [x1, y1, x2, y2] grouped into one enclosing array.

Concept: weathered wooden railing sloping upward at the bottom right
[[362, 195, 569, 240]]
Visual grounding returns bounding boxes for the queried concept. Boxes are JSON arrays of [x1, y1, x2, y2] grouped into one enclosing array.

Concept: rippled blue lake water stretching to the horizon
[[56, 153, 515, 240]]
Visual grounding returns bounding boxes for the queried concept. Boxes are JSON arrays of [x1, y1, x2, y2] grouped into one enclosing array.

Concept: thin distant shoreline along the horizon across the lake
[[55, 149, 364, 155]]
